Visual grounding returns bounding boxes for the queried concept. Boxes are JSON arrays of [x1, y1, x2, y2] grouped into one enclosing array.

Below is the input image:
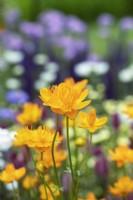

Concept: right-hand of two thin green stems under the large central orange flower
[[66, 116, 74, 186]]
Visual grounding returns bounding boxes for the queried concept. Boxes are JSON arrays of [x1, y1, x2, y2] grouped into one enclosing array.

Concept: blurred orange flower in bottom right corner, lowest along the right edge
[[109, 176, 133, 197]]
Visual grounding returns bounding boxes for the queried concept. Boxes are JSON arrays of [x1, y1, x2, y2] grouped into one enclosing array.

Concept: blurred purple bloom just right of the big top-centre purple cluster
[[66, 16, 87, 33]]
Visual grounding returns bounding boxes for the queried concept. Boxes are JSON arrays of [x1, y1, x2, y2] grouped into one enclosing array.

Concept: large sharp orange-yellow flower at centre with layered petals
[[40, 83, 90, 119]]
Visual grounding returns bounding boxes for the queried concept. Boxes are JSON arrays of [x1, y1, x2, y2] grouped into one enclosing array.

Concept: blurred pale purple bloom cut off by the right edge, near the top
[[120, 17, 133, 31]]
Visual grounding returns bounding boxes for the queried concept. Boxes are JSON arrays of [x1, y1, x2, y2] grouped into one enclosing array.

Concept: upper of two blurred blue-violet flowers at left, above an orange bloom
[[6, 90, 29, 104]]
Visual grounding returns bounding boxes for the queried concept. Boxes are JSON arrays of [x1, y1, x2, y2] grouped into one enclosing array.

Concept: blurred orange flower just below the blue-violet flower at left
[[17, 103, 43, 126]]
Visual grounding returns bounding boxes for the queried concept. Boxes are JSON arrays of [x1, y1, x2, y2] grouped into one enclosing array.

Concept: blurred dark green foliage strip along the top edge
[[1, 0, 133, 21]]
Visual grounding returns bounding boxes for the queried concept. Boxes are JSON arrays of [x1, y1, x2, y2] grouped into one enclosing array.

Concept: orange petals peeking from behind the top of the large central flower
[[64, 77, 88, 90]]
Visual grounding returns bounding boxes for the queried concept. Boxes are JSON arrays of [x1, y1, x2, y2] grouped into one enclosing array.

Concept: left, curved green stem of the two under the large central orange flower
[[52, 114, 62, 199]]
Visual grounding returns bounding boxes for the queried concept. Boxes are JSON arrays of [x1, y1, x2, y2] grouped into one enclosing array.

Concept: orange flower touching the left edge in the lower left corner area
[[0, 163, 26, 183]]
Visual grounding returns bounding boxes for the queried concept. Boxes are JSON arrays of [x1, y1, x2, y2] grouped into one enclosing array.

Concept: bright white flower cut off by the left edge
[[0, 128, 16, 151]]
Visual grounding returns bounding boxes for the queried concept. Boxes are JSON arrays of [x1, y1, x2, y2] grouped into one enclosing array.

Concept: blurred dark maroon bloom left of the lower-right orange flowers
[[95, 156, 109, 177]]
